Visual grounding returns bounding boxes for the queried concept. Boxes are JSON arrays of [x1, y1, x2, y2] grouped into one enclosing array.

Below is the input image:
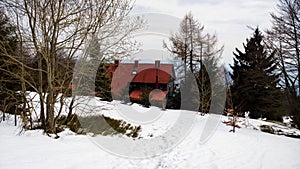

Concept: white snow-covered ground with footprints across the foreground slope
[[0, 101, 300, 169]]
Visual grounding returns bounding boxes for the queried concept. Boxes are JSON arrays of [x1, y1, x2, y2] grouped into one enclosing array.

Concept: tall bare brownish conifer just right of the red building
[[164, 13, 223, 113]]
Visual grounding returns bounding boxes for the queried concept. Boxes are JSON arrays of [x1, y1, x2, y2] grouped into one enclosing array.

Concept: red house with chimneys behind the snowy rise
[[107, 60, 175, 101]]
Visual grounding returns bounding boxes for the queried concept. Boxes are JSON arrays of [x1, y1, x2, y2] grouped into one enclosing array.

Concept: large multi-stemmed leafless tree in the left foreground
[[1, 0, 138, 133]]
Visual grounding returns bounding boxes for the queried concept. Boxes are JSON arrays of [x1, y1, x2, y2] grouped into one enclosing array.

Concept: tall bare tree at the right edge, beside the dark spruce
[[266, 0, 300, 127]]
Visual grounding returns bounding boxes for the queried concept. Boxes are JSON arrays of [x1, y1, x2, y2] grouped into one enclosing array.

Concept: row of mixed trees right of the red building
[[164, 0, 300, 128]]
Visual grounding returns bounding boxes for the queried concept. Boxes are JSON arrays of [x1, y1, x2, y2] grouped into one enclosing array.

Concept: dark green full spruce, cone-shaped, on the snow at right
[[231, 28, 281, 120]]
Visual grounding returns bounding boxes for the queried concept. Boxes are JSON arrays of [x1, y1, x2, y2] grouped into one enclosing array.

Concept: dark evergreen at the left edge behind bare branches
[[0, 10, 20, 113]]
